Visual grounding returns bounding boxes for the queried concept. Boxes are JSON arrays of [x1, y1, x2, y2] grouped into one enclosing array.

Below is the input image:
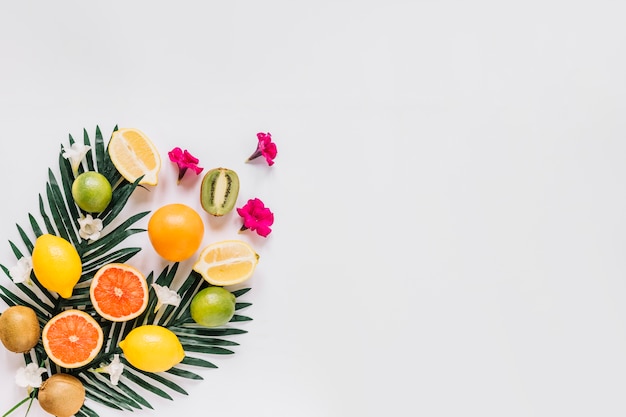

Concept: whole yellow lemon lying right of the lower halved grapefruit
[[120, 324, 185, 372]]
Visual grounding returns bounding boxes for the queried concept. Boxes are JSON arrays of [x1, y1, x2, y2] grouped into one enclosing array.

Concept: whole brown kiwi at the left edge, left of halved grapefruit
[[0, 306, 41, 353]]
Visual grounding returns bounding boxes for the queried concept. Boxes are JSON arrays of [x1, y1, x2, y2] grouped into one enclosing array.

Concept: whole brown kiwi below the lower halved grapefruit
[[37, 373, 85, 417]]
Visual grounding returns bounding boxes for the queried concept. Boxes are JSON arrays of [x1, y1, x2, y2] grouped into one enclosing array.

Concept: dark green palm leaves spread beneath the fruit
[[0, 126, 252, 417]]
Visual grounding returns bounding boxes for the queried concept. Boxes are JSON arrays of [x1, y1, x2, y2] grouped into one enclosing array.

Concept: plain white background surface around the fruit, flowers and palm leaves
[[0, 0, 626, 417]]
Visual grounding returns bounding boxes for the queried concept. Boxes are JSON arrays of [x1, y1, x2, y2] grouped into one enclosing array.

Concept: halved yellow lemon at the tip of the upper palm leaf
[[108, 128, 161, 185]]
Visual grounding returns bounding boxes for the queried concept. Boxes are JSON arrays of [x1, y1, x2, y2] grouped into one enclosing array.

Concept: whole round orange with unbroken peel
[[148, 204, 204, 262]]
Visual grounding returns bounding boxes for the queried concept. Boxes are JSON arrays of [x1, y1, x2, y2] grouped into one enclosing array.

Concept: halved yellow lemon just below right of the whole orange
[[193, 240, 259, 286]]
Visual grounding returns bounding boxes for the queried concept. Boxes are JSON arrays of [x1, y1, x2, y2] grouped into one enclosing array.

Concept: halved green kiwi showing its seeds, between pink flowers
[[200, 168, 239, 216]]
